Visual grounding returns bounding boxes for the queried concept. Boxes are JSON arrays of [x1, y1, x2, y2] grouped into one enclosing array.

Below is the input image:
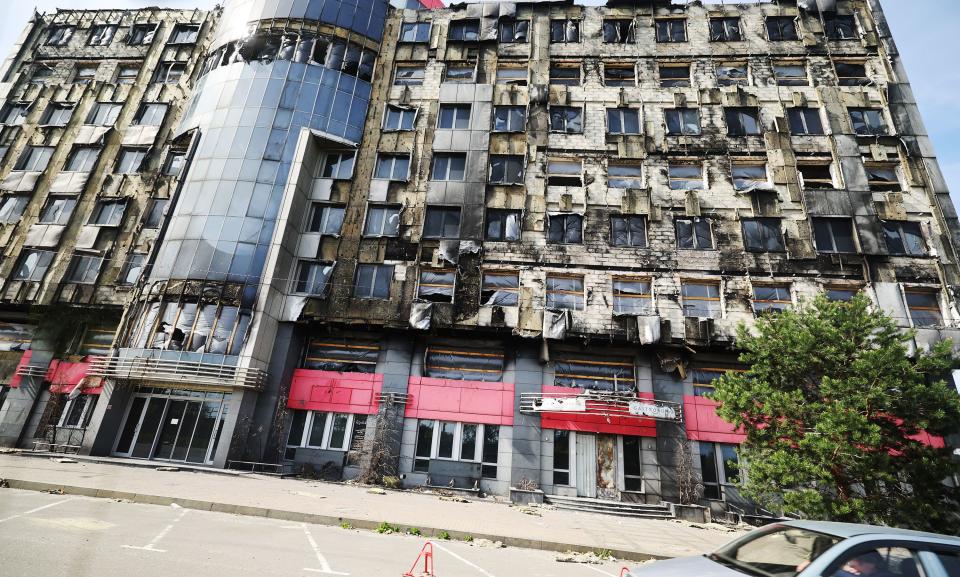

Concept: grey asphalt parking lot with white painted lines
[[0, 489, 623, 577]]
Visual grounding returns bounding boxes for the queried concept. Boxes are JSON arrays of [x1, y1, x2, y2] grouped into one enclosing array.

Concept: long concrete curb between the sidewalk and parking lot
[[3, 479, 669, 561]]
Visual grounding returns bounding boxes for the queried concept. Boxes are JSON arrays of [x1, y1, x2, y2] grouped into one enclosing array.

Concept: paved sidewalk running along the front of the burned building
[[0, 454, 736, 559]]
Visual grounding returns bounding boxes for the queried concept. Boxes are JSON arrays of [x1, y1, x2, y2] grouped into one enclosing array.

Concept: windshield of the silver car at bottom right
[[710, 527, 840, 577]]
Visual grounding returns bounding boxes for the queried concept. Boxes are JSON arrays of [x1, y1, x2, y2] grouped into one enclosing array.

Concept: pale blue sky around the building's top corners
[[0, 0, 960, 198]]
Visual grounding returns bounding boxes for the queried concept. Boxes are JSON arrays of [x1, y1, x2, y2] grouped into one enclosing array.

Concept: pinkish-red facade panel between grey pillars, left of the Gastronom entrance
[[403, 377, 513, 425]]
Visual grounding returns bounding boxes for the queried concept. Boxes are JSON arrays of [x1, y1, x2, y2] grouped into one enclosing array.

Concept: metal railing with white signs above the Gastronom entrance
[[520, 391, 683, 423]]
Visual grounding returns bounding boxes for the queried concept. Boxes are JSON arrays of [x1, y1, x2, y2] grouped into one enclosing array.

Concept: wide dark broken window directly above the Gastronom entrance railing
[[553, 353, 636, 392]]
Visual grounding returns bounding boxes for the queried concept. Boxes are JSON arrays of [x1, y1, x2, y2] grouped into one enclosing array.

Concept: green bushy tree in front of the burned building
[[713, 296, 960, 533]]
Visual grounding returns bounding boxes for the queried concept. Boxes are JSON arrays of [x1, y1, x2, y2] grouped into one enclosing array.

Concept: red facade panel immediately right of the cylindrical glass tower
[[287, 369, 383, 415]]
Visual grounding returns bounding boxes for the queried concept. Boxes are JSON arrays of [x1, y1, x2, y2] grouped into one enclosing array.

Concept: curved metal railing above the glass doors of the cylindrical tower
[[87, 357, 267, 390]]
